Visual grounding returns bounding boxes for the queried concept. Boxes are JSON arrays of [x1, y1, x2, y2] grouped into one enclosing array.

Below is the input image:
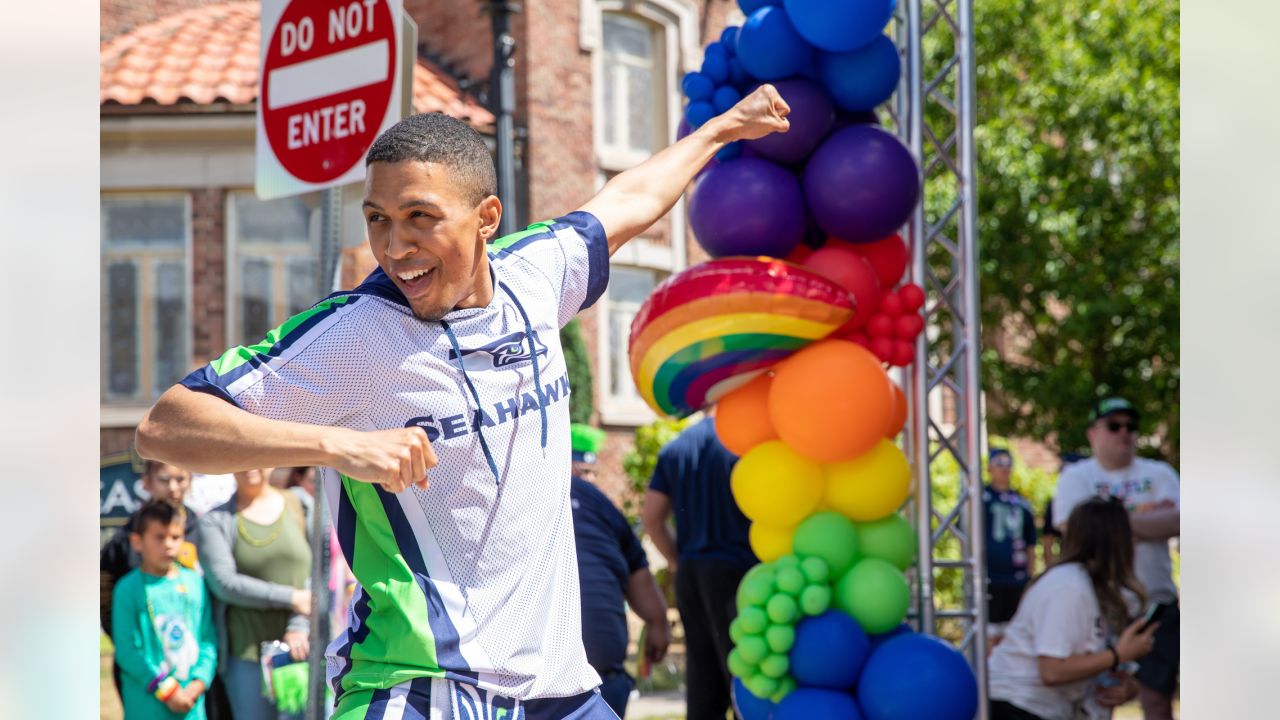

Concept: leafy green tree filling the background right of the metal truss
[[967, 0, 1179, 462]]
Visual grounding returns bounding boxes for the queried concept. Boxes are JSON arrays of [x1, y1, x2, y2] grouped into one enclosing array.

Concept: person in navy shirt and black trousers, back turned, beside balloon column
[[644, 416, 759, 720]]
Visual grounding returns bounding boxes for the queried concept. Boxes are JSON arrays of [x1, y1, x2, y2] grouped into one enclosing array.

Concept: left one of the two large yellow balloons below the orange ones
[[730, 439, 823, 528]]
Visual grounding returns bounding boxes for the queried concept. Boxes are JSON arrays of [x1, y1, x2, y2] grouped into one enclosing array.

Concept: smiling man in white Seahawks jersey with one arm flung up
[[137, 85, 790, 720]]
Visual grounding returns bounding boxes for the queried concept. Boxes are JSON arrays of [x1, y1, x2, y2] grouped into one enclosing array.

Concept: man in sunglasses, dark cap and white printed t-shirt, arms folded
[[1053, 397, 1179, 720]]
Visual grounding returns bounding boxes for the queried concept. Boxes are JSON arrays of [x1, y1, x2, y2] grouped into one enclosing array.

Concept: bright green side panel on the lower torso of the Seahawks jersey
[[342, 475, 444, 693]]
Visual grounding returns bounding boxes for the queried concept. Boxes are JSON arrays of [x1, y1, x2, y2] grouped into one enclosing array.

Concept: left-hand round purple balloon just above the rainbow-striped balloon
[[689, 156, 805, 258]]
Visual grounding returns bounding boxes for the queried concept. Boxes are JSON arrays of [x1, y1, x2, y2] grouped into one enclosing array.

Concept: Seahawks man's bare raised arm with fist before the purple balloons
[[581, 85, 791, 255]]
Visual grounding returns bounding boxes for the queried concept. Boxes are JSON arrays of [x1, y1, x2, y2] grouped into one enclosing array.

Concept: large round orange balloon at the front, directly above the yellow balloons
[[769, 338, 893, 462]]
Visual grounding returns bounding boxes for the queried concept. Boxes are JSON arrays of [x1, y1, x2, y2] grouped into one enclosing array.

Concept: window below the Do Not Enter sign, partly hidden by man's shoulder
[[227, 191, 324, 345]]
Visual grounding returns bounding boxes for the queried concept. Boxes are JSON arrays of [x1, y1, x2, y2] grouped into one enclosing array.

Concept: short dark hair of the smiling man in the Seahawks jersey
[[365, 113, 498, 205]]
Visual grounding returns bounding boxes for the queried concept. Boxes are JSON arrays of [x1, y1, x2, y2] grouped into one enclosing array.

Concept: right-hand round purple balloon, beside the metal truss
[[804, 126, 920, 242]]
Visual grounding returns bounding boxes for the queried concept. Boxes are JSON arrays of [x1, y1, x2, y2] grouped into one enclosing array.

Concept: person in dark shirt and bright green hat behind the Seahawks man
[[570, 425, 671, 717]]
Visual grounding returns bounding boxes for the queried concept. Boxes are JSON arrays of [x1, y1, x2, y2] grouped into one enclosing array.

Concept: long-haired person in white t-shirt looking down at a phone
[[987, 498, 1158, 720]]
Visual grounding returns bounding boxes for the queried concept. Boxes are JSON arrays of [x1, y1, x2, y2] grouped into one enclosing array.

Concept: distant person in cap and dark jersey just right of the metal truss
[[982, 447, 1036, 635]]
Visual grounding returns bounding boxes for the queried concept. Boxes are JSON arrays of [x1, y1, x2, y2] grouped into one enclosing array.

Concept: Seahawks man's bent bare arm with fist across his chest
[[136, 386, 435, 492]]
